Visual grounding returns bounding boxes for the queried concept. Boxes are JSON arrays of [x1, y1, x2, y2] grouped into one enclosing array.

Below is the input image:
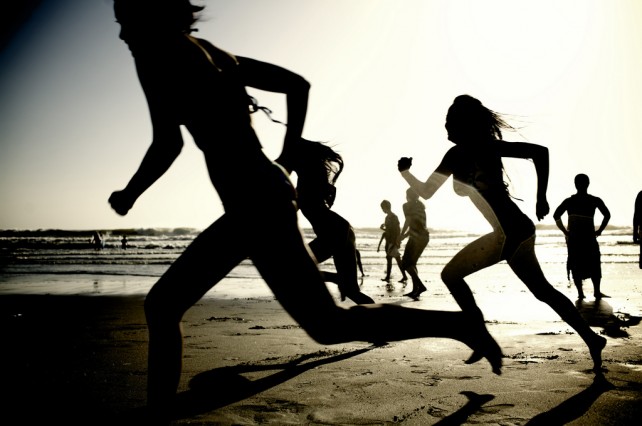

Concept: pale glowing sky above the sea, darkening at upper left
[[0, 0, 642, 230]]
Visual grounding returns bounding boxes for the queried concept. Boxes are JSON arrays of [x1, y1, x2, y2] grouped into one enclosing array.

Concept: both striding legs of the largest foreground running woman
[[145, 203, 502, 418]]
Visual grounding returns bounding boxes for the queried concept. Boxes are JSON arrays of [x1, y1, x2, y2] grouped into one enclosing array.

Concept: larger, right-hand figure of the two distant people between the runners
[[401, 188, 430, 300]]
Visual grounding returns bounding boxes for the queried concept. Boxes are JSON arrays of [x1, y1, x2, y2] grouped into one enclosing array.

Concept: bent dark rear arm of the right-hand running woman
[[498, 141, 550, 220]]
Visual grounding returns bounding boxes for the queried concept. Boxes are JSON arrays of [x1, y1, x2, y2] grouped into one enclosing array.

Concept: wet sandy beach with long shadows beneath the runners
[[0, 258, 642, 425]]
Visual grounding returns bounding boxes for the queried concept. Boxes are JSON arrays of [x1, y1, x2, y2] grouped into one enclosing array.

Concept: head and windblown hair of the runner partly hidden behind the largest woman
[[293, 139, 343, 208]]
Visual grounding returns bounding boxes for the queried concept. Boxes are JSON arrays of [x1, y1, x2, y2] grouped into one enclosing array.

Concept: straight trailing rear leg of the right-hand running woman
[[508, 237, 606, 373]]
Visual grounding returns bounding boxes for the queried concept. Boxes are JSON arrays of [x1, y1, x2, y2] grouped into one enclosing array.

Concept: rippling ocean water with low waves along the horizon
[[0, 227, 639, 297]]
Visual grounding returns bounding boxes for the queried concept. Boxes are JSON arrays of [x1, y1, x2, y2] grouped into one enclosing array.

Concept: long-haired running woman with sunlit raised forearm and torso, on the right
[[397, 95, 606, 373]]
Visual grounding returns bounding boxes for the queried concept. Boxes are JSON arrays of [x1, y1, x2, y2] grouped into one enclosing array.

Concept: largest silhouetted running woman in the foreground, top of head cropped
[[109, 0, 502, 424]]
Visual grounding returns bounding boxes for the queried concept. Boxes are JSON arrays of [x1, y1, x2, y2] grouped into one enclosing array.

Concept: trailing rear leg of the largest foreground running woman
[[251, 209, 502, 374]]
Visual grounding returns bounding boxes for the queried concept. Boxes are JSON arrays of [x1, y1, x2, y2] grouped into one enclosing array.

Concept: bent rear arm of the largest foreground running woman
[[237, 57, 310, 172]]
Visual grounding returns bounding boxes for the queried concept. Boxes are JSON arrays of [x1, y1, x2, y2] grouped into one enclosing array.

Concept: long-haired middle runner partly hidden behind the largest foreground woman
[[292, 139, 374, 304]]
